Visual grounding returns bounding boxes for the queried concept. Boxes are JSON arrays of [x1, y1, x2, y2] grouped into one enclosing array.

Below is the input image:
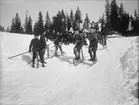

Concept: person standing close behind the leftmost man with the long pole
[[40, 31, 47, 63]]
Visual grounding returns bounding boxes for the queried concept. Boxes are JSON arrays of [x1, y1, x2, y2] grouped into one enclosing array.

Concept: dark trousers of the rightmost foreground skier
[[88, 39, 98, 61]]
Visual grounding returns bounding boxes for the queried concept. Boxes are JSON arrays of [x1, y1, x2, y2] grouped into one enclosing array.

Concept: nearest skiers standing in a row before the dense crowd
[[29, 24, 106, 67]]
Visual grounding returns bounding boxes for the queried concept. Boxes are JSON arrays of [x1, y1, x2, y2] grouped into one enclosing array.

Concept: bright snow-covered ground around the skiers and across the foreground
[[0, 32, 139, 105]]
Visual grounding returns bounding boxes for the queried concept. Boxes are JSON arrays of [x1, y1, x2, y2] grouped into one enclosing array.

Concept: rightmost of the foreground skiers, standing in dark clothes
[[88, 27, 99, 62]]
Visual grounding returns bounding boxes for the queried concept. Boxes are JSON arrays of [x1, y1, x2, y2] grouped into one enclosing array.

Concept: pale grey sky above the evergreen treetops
[[0, 0, 139, 27]]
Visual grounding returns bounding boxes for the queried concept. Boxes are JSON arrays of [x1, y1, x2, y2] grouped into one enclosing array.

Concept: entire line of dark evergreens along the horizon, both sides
[[0, 0, 139, 35]]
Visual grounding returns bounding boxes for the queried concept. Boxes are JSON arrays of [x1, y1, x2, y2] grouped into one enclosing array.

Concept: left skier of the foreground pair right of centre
[[74, 30, 84, 60]]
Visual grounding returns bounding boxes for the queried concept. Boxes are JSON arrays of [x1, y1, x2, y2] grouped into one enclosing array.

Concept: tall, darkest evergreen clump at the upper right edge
[[105, 0, 139, 35]]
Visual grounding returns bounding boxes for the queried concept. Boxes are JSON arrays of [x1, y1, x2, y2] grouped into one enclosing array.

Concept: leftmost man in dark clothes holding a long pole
[[29, 35, 45, 68]]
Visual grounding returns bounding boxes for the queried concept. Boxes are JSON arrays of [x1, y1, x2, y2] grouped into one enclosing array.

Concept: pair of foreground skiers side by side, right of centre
[[74, 27, 99, 62]]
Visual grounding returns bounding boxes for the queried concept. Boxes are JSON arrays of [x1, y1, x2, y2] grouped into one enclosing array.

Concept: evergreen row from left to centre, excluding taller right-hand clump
[[10, 7, 82, 34]]
